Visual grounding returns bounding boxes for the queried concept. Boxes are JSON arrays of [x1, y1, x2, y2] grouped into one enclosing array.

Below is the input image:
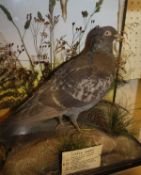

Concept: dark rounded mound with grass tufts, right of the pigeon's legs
[[80, 100, 132, 136]]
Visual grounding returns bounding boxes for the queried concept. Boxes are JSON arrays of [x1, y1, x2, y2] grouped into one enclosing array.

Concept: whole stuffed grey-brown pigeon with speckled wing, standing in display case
[[0, 26, 117, 133]]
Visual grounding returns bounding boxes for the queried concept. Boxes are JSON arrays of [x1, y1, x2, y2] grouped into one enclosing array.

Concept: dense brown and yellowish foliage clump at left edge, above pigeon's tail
[[0, 43, 36, 108]]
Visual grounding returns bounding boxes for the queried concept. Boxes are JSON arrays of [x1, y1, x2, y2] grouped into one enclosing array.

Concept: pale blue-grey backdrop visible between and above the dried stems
[[0, 0, 118, 65]]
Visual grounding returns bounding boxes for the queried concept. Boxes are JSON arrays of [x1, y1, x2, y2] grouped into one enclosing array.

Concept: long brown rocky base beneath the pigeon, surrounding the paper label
[[3, 129, 141, 175]]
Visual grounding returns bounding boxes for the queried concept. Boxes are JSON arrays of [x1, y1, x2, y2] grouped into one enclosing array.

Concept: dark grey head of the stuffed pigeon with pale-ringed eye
[[85, 26, 118, 53]]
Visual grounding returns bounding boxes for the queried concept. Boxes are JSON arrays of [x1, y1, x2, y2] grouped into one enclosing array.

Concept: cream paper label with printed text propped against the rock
[[62, 145, 102, 175]]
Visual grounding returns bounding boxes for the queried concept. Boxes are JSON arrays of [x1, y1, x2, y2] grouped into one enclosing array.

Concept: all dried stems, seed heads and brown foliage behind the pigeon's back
[[0, 0, 103, 108]]
